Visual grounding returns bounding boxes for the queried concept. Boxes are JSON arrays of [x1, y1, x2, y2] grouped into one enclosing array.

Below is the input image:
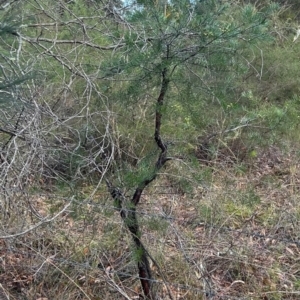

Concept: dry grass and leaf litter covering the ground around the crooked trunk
[[0, 147, 300, 300]]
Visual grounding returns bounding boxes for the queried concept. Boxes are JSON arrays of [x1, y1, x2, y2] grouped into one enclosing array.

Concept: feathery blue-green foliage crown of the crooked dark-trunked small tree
[[107, 1, 277, 181]]
